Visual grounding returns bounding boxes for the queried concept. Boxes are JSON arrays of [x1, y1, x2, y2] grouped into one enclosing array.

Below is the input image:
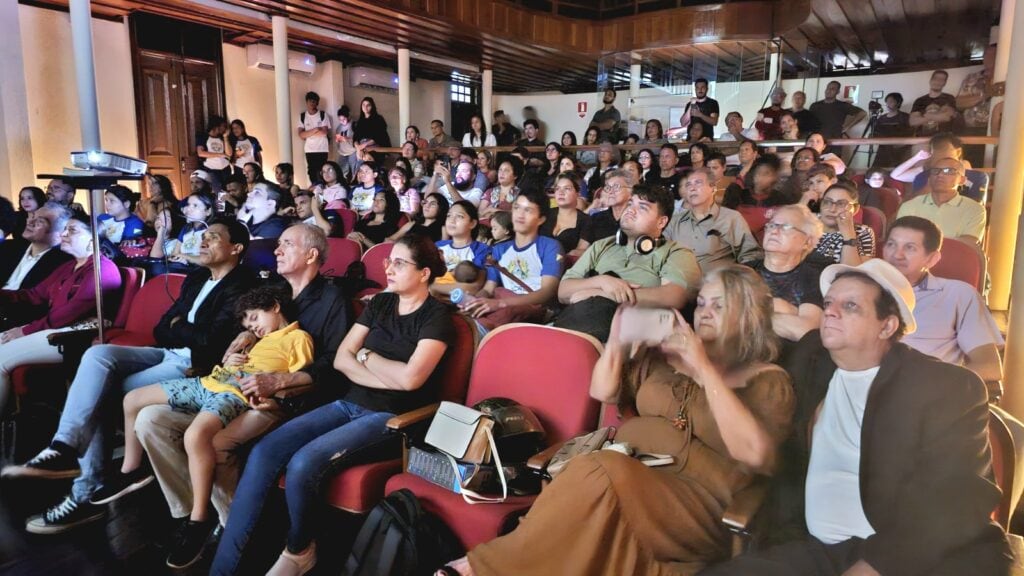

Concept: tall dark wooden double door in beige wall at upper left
[[132, 14, 224, 198]]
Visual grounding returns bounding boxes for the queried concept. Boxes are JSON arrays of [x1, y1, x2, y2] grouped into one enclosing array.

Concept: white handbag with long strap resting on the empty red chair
[[424, 402, 508, 504]]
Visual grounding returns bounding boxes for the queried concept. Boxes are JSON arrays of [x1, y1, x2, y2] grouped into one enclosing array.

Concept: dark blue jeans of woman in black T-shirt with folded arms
[[210, 400, 393, 574]]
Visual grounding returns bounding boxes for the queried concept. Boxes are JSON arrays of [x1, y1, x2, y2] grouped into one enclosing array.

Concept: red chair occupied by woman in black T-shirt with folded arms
[[317, 314, 478, 513]]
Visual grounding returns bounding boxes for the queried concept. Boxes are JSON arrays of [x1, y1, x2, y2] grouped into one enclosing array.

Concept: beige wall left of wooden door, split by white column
[[19, 5, 138, 192]]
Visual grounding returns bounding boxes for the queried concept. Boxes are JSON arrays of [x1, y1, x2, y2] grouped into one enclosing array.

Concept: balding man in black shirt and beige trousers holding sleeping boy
[[135, 223, 349, 565]]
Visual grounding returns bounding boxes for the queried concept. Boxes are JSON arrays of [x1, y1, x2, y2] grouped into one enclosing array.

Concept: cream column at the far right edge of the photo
[[988, 0, 1024, 418]]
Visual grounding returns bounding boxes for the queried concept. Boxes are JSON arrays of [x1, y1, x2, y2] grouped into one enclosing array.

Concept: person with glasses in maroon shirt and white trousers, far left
[[0, 208, 121, 411]]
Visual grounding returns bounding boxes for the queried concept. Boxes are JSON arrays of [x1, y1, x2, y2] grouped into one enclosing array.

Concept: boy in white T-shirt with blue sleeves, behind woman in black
[[460, 189, 562, 331]]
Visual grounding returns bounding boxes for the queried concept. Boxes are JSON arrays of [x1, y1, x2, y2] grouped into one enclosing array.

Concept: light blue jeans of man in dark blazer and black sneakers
[[53, 344, 191, 502]]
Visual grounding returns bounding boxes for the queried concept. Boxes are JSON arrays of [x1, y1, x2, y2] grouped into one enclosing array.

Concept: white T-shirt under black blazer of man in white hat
[[804, 367, 879, 544]]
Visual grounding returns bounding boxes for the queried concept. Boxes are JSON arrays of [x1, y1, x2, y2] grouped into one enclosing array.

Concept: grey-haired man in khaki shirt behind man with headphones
[[665, 168, 764, 272]]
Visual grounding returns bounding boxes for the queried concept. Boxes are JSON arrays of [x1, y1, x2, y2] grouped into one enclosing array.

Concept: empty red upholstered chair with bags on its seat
[[386, 324, 601, 549]]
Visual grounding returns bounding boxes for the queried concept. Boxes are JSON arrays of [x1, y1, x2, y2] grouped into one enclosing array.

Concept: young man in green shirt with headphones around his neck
[[555, 184, 700, 341]]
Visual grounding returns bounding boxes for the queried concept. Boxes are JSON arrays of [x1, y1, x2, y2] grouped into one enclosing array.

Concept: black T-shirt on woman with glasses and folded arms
[[345, 292, 455, 414]]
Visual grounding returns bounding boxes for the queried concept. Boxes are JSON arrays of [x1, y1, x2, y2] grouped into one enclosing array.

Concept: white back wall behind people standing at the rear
[[494, 66, 981, 158]]
